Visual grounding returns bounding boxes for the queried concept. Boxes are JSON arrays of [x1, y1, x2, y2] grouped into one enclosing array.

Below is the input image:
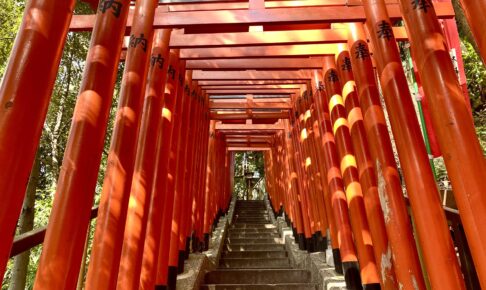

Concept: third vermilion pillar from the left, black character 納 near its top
[[86, 1, 159, 289]]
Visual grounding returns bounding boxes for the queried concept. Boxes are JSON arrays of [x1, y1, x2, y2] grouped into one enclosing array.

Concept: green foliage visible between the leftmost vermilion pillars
[[0, 0, 119, 290]]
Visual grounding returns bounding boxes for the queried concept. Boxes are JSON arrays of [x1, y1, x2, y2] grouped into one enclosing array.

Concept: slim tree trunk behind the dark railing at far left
[[8, 150, 40, 290]]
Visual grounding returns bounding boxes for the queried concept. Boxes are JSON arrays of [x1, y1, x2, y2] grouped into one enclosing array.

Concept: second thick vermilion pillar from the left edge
[[34, 1, 133, 289]]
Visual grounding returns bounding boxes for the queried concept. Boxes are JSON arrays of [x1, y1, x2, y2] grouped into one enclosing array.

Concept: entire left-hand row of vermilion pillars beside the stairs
[[0, 1, 231, 289]]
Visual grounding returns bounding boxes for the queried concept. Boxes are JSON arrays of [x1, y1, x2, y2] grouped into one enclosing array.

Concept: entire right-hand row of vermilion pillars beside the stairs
[[265, 9, 486, 290]]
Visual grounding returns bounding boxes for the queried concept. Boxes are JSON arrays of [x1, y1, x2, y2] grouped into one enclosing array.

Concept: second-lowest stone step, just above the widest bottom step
[[219, 258, 291, 269]]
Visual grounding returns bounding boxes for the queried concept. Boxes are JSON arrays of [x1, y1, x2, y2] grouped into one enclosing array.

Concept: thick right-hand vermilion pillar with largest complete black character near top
[[363, 0, 465, 289]]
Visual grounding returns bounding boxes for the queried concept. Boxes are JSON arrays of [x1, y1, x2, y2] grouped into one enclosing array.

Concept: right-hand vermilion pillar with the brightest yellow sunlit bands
[[324, 58, 380, 289]]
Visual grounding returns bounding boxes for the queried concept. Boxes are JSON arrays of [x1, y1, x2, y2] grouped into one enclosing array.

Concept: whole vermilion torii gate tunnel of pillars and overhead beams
[[0, 0, 486, 290]]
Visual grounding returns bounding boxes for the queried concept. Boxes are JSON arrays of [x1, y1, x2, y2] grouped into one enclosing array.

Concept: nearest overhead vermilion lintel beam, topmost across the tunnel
[[69, 2, 454, 31]]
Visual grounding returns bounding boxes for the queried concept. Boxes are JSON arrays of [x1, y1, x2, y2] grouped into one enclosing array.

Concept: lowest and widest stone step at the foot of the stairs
[[205, 269, 311, 284]]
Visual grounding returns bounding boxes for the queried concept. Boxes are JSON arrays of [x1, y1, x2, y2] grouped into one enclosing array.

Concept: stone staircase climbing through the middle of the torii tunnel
[[201, 200, 316, 290]]
